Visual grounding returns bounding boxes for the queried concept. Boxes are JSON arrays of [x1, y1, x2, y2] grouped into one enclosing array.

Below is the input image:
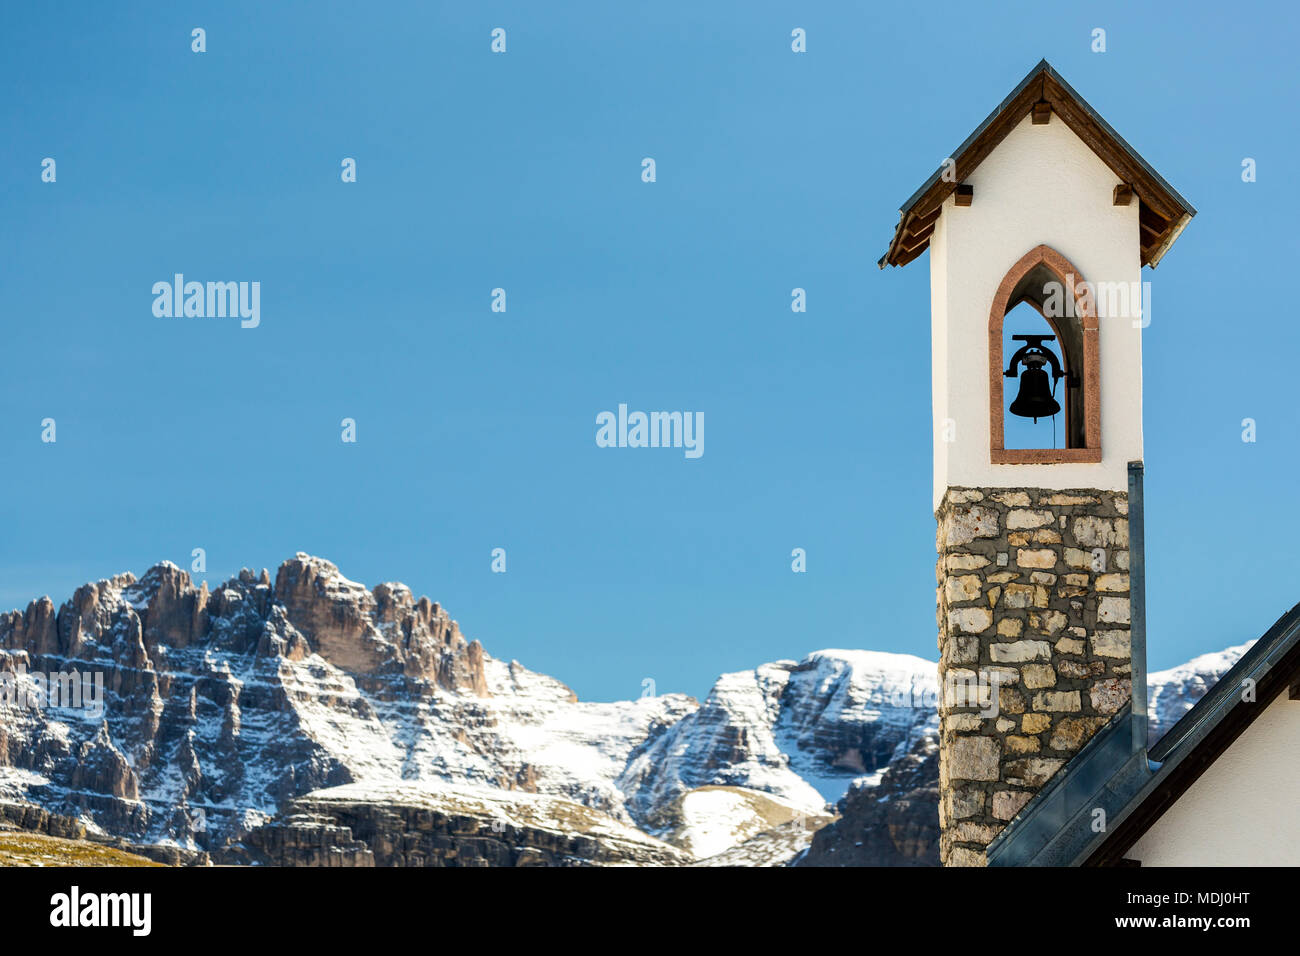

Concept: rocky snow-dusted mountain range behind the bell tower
[[0, 554, 1244, 865]]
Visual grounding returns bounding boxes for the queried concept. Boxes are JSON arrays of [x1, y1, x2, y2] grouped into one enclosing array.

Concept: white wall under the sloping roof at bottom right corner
[[1127, 692, 1300, 866]]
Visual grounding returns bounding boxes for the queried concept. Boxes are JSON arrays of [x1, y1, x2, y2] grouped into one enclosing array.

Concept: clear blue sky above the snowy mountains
[[0, 3, 1300, 698]]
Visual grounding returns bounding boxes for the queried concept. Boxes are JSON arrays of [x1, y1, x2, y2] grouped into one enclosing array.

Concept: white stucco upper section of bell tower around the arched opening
[[930, 116, 1143, 509]]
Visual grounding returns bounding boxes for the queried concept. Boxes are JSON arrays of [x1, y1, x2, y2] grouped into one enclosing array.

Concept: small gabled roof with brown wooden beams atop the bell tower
[[878, 60, 1196, 269]]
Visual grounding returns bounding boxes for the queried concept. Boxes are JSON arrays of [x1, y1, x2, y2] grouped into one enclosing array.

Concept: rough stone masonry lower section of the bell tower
[[936, 488, 1131, 866]]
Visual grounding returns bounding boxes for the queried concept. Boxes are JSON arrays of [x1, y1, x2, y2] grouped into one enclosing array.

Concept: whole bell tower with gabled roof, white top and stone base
[[879, 60, 1195, 866]]
